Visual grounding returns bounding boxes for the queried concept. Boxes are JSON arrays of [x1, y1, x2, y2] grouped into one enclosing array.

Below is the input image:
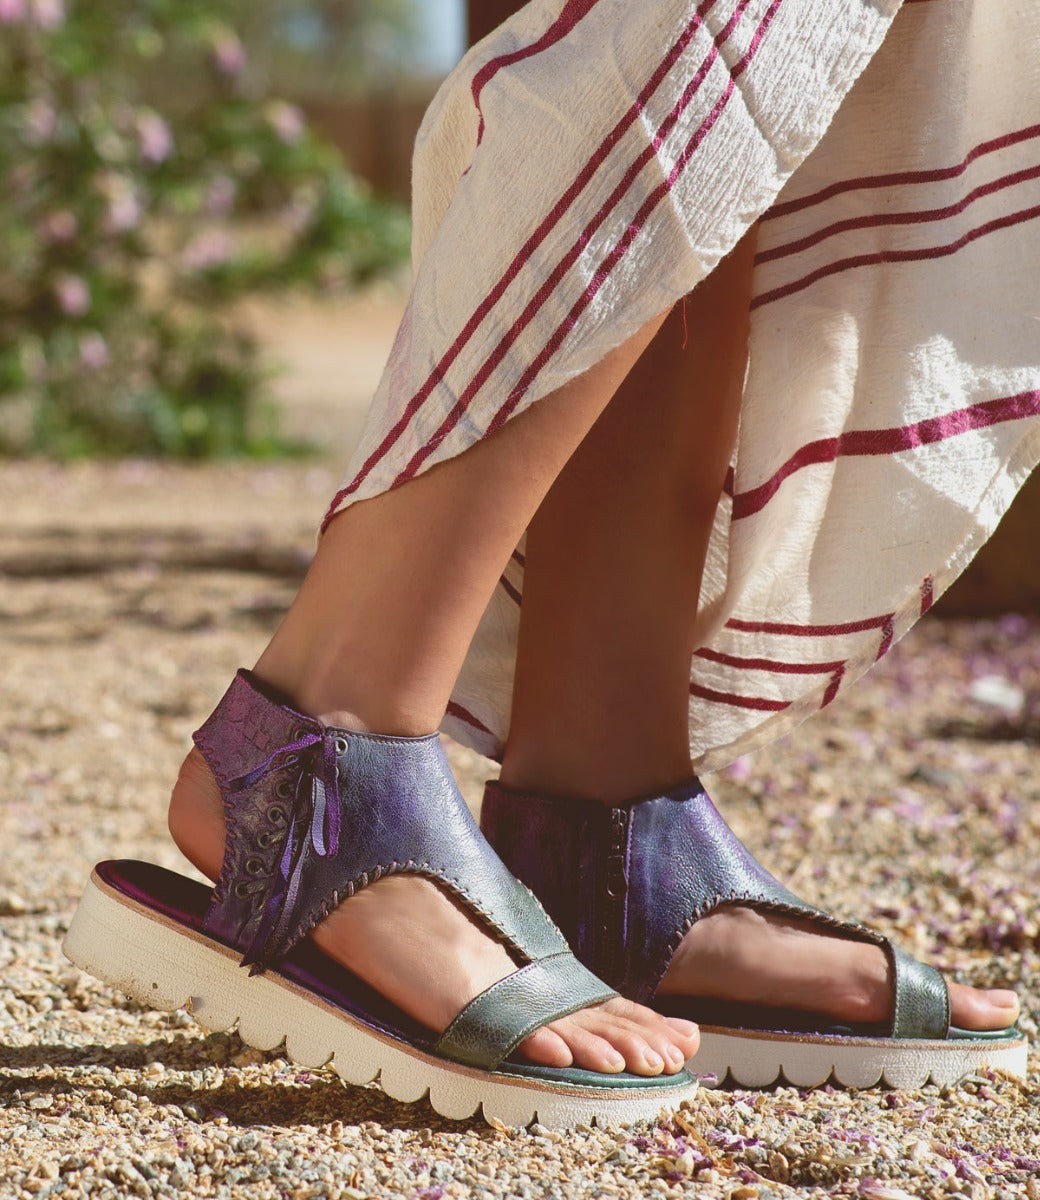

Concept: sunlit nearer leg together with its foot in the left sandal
[[170, 309, 693, 1074]]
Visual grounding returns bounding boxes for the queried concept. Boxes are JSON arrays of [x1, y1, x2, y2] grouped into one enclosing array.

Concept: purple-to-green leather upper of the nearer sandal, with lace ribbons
[[194, 671, 617, 1069]]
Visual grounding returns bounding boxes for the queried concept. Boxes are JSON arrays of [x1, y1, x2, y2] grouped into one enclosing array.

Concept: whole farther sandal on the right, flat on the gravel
[[481, 779, 1028, 1088]]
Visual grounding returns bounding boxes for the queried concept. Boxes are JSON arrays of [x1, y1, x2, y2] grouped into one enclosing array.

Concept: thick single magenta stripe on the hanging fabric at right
[[733, 391, 1040, 521]]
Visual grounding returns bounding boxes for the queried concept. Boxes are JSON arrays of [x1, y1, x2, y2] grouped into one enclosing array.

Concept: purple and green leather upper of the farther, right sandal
[[481, 779, 950, 1038]]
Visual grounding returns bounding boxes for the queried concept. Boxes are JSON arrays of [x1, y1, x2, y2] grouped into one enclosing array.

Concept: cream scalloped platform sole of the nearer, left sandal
[[62, 876, 698, 1129]]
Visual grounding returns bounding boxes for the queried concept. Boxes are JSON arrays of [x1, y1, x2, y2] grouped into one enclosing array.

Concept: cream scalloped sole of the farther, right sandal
[[686, 1026, 1029, 1091]]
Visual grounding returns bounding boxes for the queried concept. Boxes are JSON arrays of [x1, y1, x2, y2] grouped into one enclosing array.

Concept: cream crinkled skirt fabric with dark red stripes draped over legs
[[330, 0, 1040, 769]]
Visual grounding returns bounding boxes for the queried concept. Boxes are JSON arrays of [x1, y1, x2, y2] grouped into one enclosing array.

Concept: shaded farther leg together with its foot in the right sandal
[[503, 238, 1017, 1030]]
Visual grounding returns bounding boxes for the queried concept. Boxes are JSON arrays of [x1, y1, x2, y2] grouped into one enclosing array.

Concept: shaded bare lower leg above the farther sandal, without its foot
[[503, 230, 755, 802]]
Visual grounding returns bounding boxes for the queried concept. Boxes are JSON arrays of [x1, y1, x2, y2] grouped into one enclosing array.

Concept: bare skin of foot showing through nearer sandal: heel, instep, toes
[[169, 750, 698, 1075]]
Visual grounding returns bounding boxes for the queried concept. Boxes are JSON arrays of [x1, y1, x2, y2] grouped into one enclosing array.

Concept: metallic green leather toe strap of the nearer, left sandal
[[434, 953, 618, 1070]]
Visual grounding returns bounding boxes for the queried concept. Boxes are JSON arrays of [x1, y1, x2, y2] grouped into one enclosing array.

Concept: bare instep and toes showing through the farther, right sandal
[[659, 906, 1018, 1030]]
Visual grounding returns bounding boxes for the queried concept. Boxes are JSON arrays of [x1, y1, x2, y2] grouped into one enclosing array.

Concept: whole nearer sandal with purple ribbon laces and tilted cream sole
[[64, 671, 697, 1128]]
